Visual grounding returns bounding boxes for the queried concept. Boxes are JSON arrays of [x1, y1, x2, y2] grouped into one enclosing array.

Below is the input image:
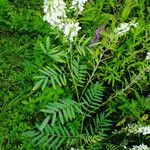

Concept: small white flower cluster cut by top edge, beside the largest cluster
[[70, 0, 87, 14]]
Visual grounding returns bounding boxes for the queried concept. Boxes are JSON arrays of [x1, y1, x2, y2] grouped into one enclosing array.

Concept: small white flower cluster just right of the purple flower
[[114, 22, 138, 36]]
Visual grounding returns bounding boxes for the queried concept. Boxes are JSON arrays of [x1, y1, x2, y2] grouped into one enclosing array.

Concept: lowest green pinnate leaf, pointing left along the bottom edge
[[23, 124, 83, 150]]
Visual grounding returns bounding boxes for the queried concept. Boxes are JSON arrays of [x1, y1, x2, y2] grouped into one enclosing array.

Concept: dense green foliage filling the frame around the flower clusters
[[0, 0, 150, 150]]
